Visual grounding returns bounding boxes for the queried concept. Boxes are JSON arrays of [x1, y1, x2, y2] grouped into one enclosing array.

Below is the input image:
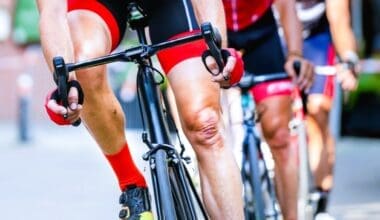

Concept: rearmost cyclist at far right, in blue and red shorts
[[297, 0, 358, 216]]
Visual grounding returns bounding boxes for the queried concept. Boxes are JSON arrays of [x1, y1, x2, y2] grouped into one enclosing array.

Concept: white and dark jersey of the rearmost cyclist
[[296, 0, 328, 37]]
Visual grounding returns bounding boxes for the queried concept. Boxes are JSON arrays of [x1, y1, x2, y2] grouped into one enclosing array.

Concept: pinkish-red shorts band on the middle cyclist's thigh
[[251, 79, 294, 103]]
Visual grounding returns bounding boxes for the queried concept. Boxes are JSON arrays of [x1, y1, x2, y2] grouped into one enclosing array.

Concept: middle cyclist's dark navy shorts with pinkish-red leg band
[[228, 8, 293, 103]]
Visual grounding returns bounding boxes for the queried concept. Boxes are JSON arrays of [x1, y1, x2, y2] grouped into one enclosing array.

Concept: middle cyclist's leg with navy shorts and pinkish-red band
[[244, 28, 298, 219]]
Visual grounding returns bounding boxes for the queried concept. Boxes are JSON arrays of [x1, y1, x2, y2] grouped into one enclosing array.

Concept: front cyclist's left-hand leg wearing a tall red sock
[[63, 2, 149, 215]]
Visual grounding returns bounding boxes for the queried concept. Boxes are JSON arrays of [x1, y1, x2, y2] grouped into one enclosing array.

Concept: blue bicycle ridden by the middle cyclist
[[238, 72, 289, 220]]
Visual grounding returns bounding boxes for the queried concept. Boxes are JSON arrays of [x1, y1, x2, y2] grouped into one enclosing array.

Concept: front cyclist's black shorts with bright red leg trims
[[68, 0, 206, 73]]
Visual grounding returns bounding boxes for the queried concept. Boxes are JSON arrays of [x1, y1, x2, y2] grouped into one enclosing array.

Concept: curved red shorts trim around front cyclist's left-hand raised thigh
[[67, 0, 121, 50]]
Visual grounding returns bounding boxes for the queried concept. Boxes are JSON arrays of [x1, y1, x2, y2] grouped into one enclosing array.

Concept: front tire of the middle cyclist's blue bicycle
[[242, 135, 266, 220]]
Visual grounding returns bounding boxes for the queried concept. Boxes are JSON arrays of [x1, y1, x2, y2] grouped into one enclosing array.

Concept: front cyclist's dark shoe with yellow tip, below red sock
[[119, 186, 153, 220]]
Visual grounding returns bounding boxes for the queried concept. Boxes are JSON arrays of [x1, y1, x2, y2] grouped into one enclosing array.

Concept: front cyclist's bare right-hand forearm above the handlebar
[[191, 0, 227, 48]]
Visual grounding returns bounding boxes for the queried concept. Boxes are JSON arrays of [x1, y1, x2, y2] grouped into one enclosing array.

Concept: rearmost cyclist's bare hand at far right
[[336, 63, 360, 91]]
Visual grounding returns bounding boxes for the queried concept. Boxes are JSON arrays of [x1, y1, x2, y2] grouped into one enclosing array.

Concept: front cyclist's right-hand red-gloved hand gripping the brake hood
[[206, 48, 244, 88]]
